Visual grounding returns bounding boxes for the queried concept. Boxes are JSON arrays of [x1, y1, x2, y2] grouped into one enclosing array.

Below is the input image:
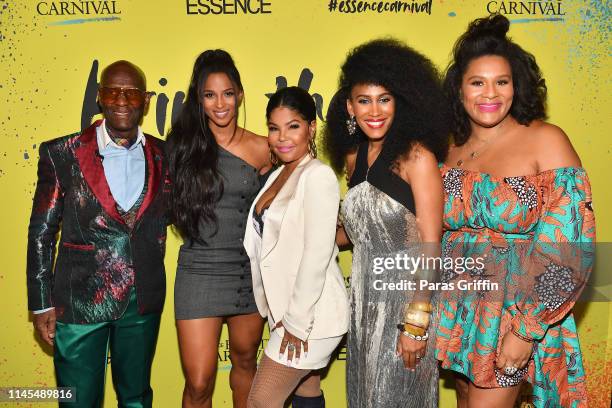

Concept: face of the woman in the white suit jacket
[[268, 106, 317, 164]]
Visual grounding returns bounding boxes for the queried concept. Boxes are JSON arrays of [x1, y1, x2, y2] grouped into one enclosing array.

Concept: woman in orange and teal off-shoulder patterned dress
[[436, 15, 595, 408]]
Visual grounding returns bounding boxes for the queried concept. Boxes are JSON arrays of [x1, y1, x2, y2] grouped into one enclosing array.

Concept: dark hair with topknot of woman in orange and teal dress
[[443, 14, 546, 146]]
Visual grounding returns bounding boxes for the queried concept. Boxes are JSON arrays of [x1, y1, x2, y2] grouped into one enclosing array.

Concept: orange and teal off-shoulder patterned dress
[[436, 165, 595, 407]]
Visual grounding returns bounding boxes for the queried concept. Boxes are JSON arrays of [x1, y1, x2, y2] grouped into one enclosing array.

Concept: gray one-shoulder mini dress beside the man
[[174, 147, 262, 320]]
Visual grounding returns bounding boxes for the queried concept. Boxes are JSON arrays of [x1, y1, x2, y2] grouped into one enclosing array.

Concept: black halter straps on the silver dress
[[349, 141, 416, 214]]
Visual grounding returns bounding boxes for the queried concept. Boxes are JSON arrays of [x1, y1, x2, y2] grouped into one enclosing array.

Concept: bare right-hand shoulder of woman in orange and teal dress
[[527, 121, 582, 172]]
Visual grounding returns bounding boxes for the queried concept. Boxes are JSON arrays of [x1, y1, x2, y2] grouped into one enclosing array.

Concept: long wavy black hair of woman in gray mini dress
[[167, 50, 243, 243]]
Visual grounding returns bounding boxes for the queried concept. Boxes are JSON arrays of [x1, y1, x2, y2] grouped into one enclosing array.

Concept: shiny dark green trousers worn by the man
[[53, 289, 160, 408]]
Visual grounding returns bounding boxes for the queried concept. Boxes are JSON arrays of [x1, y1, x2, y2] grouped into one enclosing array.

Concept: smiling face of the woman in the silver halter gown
[[346, 84, 395, 140]]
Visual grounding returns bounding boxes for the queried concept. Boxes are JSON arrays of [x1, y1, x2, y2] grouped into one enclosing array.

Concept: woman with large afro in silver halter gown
[[324, 39, 449, 408]]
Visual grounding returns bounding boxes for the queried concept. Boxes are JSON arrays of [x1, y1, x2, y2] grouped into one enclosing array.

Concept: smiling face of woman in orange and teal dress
[[461, 55, 514, 128]]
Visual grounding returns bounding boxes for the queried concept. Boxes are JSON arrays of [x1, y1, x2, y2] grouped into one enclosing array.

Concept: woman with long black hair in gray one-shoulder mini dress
[[168, 50, 271, 407]]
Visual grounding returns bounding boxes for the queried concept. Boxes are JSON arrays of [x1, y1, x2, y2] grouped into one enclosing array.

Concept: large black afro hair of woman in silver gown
[[323, 38, 450, 173]]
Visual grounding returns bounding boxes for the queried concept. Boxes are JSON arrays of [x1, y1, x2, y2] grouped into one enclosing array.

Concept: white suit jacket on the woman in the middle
[[244, 155, 348, 341]]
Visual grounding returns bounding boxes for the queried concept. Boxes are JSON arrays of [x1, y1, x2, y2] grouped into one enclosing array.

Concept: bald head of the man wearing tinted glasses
[[98, 62, 151, 138]]
